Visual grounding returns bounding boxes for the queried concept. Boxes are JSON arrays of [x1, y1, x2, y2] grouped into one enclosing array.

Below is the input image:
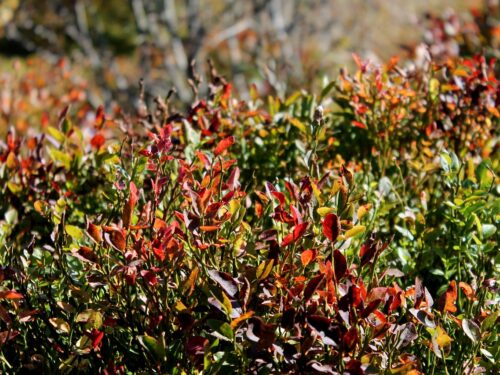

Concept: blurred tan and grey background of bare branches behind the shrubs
[[0, 0, 498, 108]]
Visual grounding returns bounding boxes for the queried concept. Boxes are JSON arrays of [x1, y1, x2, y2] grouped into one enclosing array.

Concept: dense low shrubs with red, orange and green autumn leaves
[[0, 2, 500, 374]]
